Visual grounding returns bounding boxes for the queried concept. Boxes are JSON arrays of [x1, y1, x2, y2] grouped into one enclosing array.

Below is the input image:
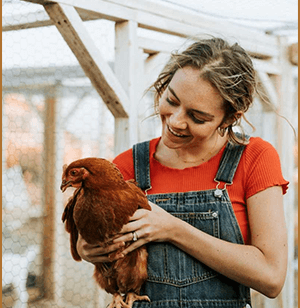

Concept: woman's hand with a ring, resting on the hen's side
[[113, 201, 176, 255]]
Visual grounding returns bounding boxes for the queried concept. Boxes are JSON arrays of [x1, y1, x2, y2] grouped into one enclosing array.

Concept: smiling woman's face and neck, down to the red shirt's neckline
[[156, 66, 228, 167]]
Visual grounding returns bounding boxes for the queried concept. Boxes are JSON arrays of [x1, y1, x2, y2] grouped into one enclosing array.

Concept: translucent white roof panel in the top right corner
[[157, 0, 298, 41]]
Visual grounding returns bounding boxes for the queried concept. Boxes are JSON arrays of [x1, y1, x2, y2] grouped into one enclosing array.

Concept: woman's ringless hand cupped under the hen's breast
[[76, 234, 125, 263]]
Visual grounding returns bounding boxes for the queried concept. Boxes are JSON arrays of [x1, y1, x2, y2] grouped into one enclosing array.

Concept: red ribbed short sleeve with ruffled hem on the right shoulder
[[245, 137, 289, 199]]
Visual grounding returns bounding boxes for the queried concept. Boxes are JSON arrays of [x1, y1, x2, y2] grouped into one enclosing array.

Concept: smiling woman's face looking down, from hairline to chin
[[159, 67, 225, 149]]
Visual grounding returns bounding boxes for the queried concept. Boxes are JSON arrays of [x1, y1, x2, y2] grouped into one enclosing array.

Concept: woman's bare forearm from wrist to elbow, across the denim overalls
[[168, 215, 286, 297]]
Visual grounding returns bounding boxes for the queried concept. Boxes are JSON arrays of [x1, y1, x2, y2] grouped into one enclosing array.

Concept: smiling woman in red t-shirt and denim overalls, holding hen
[[77, 38, 288, 307]]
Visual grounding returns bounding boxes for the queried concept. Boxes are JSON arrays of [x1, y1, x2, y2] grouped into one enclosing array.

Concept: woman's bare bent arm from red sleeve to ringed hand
[[114, 186, 287, 298]]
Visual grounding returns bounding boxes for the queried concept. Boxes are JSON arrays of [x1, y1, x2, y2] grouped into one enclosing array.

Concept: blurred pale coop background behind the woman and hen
[[2, 0, 298, 308]]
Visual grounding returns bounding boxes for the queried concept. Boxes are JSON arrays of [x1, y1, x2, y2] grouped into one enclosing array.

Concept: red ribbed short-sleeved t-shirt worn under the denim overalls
[[113, 137, 289, 244]]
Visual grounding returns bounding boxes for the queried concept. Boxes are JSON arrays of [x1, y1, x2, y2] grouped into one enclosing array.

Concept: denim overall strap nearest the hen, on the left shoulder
[[132, 141, 151, 191]]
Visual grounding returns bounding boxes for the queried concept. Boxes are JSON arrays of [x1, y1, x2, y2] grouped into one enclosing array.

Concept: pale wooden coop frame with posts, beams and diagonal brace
[[3, 0, 298, 308]]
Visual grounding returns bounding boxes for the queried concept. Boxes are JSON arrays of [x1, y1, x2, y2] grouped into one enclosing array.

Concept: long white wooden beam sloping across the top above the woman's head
[[25, 0, 278, 57]]
